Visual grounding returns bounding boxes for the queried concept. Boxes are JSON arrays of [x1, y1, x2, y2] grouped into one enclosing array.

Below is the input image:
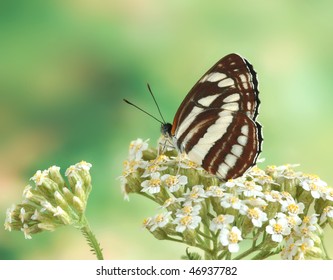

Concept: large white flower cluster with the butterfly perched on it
[[120, 139, 333, 259]]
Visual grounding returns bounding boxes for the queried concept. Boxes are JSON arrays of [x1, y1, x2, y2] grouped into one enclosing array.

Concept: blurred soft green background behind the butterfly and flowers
[[0, 0, 333, 259]]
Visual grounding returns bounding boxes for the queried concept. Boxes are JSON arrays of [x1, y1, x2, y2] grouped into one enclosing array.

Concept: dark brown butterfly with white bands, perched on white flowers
[[126, 54, 263, 181]]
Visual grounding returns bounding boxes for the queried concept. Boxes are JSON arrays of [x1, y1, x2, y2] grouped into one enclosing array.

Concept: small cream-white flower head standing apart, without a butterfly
[[4, 161, 91, 239]]
